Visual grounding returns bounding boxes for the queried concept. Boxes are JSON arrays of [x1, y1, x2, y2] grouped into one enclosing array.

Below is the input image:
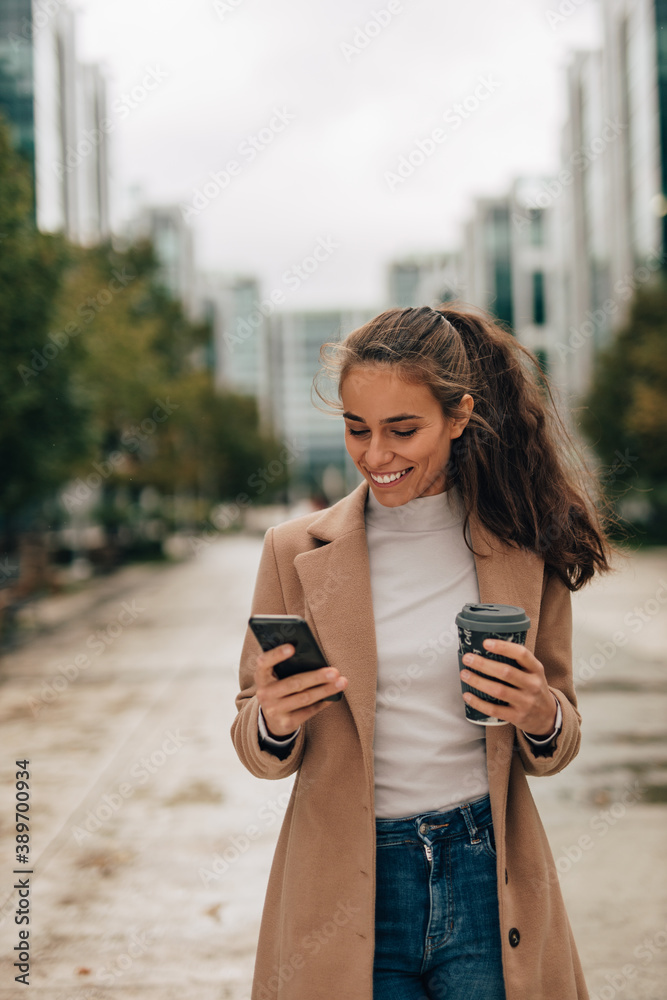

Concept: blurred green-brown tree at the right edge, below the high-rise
[[582, 275, 667, 540]]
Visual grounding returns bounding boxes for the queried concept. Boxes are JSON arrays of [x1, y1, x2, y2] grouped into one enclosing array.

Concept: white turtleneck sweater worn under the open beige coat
[[259, 489, 560, 818]]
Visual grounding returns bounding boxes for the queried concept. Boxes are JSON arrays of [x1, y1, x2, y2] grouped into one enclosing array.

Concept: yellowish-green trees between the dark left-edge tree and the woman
[[59, 244, 287, 528]]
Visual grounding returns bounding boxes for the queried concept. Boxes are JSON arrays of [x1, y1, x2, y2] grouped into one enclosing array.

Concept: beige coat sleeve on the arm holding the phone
[[231, 528, 306, 779]]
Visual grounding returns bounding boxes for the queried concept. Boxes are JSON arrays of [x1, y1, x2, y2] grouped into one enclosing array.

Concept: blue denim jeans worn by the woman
[[373, 795, 505, 1000]]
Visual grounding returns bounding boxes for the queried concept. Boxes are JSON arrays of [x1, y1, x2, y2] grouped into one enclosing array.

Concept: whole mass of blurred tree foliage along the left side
[[0, 111, 286, 540]]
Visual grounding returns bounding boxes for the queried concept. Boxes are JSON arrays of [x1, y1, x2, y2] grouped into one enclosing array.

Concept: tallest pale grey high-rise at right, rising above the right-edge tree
[[557, 0, 667, 401]]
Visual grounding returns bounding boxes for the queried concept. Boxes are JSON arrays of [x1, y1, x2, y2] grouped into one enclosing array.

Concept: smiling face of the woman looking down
[[341, 364, 473, 507]]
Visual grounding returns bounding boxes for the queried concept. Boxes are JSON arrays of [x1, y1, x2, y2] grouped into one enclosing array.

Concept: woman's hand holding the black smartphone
[[254, 644, 348, 739]]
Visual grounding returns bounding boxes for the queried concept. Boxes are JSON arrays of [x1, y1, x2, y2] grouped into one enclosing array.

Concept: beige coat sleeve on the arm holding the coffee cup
[[515, 574, 581, 776]]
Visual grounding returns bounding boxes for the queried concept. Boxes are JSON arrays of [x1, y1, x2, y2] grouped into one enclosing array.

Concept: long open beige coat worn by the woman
[[231, 482, 588, 1000]]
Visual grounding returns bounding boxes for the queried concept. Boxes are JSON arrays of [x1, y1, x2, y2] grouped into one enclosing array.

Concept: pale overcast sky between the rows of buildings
[[75, 0, 600, 309]]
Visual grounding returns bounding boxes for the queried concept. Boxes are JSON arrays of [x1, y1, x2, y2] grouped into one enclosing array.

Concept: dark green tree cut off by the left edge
[[0, 118, 88, 534]]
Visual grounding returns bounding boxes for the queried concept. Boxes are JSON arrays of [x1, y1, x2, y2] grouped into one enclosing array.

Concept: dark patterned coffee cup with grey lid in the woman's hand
[[456, 604, 530, 726]]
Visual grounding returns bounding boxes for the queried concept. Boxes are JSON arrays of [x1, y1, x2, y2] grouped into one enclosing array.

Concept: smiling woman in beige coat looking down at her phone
[[231, 304, 611, 1000]]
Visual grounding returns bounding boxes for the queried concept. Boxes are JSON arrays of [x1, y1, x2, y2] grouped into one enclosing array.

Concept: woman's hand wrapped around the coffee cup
[[461, 639, 558, 739]]
